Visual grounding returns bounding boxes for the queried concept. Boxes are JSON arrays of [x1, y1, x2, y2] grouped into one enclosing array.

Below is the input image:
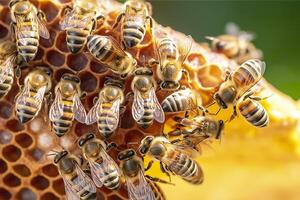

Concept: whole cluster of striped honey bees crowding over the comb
[[0, 0, 269, 200]]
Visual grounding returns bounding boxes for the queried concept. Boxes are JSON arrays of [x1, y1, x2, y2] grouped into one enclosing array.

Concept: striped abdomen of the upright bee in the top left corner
[[16, 21, 40, 62]]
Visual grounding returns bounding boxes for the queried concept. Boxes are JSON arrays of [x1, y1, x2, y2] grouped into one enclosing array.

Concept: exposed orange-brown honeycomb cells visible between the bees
[[0, 0, 298, 200]]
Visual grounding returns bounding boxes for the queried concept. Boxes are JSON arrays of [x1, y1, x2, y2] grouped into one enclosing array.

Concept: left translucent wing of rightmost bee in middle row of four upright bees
[[131, 88, 145, 121]]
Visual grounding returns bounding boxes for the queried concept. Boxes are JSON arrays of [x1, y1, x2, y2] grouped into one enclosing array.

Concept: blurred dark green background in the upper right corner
[[150, 0, 300, 99]]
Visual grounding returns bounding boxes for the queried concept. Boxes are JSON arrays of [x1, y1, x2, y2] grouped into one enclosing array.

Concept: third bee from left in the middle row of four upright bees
[[86, 79, 124, 139]]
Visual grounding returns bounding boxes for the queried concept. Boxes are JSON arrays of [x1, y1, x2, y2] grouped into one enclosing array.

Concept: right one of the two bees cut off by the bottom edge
[[118, 149, 155, 200]]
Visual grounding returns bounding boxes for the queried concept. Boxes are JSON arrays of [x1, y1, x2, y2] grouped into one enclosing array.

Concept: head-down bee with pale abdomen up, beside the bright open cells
[[153, 36, 192, 90]]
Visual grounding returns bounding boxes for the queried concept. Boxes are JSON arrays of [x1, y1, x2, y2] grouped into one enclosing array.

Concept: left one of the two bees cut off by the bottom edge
[[54, 151, 96, 200]]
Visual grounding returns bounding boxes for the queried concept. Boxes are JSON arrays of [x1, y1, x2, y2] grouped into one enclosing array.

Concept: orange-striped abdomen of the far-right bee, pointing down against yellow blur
[[238, 99, 269, 127]]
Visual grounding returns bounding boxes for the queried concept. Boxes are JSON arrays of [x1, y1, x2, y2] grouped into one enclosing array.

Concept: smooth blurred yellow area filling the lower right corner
[[149, 82, 300, 200]]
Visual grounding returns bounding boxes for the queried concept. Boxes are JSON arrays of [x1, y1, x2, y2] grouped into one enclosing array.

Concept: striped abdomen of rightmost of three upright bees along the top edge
[[122, 20, 146, 48]]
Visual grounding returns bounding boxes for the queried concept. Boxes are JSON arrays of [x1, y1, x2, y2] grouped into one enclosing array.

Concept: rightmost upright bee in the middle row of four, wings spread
[[131, 67, 165, 128]]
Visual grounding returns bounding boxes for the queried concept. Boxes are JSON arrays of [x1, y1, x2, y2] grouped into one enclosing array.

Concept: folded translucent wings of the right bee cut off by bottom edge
[[125, 170, 155, 200]]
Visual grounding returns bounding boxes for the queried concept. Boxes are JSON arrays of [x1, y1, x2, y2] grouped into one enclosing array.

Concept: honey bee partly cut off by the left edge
[[0, 41, 17, 98]]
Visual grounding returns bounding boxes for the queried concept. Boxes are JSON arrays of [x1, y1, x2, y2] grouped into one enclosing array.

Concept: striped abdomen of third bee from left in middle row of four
[[98, 103, 118, 138]]
